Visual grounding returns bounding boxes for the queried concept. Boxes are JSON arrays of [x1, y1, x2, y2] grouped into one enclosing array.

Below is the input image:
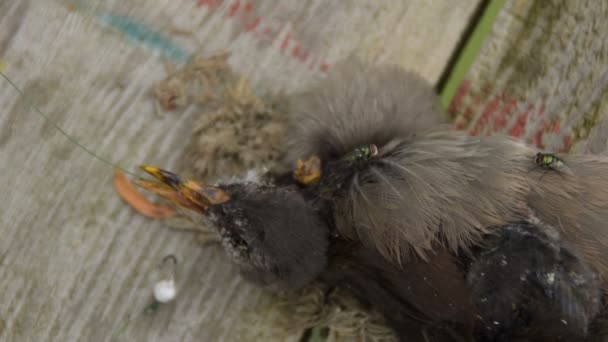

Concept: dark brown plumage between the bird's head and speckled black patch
[[320, 239, 477, 341]]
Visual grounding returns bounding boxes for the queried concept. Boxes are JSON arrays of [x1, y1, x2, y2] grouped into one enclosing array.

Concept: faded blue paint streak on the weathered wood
[[98, 14, 190, 63]]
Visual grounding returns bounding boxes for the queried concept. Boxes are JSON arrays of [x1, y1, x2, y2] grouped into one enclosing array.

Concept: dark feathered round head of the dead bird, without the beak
[[208, 183, 329, 289]]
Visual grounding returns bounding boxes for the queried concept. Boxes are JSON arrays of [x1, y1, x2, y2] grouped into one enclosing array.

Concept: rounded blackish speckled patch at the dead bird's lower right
[[467, 222, 601, 341]]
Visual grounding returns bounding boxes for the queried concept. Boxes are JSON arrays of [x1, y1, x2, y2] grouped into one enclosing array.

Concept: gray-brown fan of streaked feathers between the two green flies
[[335, 130, 529, 263]]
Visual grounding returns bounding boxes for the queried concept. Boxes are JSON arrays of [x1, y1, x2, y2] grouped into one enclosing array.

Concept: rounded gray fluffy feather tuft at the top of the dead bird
[[287, 59, 447, 165]]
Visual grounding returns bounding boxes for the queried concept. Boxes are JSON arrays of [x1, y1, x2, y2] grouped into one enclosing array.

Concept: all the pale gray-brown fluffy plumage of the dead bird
[[286, 60, 608, 278]]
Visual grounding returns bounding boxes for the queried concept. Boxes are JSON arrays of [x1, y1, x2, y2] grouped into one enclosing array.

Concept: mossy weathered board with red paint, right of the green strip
[[450, 0, 608, 153]]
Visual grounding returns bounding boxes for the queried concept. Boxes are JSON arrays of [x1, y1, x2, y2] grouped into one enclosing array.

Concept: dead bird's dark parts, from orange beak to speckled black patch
[[139, 167, 600, 341]]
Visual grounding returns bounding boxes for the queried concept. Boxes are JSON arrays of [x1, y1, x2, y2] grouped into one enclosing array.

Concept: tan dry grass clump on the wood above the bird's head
[[154, 52, 286, 180]]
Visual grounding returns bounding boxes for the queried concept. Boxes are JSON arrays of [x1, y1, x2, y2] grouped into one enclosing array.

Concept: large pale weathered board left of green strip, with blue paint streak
[[0, 0, 477, 341]]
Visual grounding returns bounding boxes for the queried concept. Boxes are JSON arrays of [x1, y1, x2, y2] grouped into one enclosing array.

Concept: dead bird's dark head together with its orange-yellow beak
[[137, 166, 329, 288]]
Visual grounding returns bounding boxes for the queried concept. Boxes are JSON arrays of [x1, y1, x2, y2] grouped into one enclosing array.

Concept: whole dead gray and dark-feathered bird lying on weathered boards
[[138, 61, 608, 341]]
